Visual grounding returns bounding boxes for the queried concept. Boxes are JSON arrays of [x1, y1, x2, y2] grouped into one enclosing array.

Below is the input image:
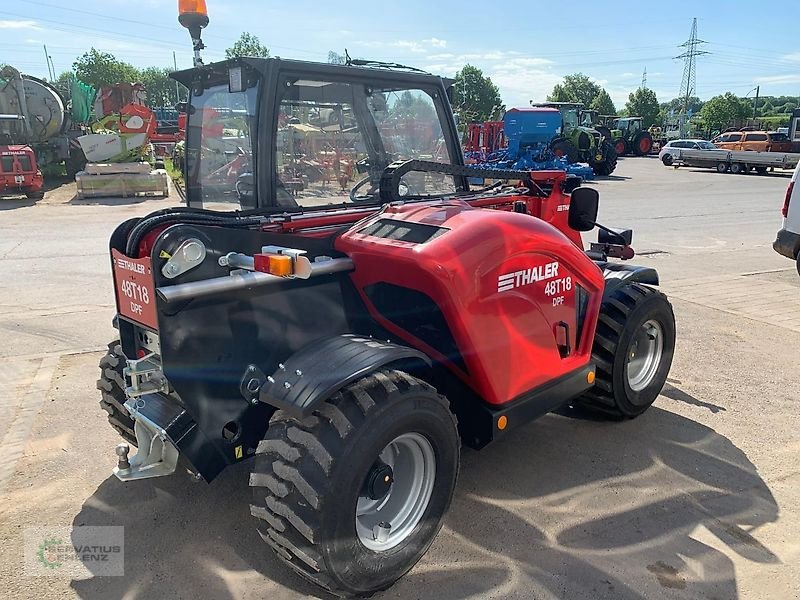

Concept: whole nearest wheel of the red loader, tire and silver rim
[[250, 369, 460, 595]]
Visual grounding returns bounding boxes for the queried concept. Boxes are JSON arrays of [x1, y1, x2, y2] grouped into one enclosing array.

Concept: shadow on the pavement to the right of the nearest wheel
[[386, 407, 780, 600]]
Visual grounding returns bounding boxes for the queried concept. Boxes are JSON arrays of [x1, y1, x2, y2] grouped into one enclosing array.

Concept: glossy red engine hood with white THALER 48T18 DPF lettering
[[336, 178, 604, 405]]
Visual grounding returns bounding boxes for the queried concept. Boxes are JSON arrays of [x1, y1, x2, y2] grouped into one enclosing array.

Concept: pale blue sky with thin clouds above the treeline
[[0, 0, 800, 109]]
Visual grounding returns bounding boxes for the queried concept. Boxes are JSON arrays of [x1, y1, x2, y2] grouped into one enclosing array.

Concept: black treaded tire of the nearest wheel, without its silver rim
[[250, 369, 460, 597]]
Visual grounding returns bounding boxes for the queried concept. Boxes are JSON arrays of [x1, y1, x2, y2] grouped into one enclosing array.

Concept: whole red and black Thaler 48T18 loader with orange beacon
[[98, 0, 675, 596]]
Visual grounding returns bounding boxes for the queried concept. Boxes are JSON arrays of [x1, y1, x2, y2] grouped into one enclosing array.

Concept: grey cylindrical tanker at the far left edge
[[0, 66, 86, 177]]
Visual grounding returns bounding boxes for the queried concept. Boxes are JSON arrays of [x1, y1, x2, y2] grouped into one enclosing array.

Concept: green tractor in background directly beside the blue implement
[[531, 102, 617, 175]]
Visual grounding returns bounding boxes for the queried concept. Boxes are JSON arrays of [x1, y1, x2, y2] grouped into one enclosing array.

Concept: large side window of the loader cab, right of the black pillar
[[274, 79, 455, 208]]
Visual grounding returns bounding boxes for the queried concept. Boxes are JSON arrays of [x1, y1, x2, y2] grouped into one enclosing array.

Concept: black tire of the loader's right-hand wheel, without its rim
[[579, 283, 675, 419]]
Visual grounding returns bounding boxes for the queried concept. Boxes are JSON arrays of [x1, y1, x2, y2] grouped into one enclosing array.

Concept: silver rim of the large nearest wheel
[[356, 433, 436, 552]]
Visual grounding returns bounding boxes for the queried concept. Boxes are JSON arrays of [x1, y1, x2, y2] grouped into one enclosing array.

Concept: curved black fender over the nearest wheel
[[256, 334, 431, 419]]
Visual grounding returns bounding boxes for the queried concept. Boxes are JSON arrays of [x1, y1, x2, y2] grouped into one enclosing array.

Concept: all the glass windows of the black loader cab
[[185, 76, 456, 210]]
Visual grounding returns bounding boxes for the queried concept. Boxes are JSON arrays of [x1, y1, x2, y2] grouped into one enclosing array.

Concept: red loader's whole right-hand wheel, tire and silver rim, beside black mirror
[[579, 283, 675, 418]]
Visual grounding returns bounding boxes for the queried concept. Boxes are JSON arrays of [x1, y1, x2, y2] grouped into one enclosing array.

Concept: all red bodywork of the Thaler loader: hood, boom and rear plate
[[125, 171, 604, 405]]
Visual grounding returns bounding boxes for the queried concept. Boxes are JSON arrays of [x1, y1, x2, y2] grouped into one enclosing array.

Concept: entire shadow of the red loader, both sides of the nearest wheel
[[72, 408, 778, 600]]
